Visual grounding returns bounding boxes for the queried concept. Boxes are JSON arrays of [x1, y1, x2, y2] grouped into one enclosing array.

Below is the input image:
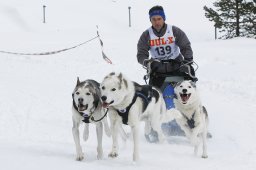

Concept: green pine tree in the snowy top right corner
[[204, 0, 256, 39]]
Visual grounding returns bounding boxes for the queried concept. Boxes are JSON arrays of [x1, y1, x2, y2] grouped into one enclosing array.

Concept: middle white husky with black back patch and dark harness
[[100, 72, 174, 161]]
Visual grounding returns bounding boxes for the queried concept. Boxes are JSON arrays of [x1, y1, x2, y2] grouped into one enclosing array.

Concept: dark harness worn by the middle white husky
[[116, 84, 154, 125]]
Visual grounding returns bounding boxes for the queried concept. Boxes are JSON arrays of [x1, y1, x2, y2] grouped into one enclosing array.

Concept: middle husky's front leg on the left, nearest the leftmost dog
[[108, 119, 119, 158]]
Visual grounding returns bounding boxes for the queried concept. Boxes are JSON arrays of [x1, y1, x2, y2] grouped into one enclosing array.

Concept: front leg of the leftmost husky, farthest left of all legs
[[72, 119, 84, 161]]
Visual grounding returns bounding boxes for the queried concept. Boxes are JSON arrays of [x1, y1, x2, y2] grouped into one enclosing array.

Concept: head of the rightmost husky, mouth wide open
[[174, 80, 197, 104]]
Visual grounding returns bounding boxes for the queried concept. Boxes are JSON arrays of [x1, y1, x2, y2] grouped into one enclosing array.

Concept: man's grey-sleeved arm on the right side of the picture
[[172, 26, 193, 61]]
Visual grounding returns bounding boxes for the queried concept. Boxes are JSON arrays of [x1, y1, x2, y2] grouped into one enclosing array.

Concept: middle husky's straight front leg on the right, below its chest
[[131, 123, 139, 162]]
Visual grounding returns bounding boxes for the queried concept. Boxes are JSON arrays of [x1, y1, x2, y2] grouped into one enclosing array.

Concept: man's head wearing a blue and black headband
[[148, 6, 165, 31]]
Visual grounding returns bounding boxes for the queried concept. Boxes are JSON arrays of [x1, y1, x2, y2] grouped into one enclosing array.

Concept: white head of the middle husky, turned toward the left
[[100, 72, 129, 108]]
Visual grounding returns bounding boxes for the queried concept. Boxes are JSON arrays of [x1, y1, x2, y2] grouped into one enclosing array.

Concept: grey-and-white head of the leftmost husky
[[72, 78, 100, 117]]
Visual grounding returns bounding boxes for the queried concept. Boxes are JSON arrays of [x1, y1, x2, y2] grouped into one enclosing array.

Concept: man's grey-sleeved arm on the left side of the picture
[[137, 30, 150, 65]]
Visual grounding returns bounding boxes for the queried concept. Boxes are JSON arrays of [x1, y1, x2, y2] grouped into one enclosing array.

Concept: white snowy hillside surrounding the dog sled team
[[0, 0, 256, 170]]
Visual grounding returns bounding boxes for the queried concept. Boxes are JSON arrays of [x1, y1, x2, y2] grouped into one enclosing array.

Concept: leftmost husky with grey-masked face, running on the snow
[[72, 78, 111, 161]]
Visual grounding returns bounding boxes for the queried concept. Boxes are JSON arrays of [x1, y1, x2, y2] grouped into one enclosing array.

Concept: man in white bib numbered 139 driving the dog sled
[[137, 6, 197, 88]]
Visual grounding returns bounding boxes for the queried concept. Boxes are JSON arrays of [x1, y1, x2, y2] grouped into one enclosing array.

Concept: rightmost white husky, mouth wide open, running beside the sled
[[174, 80, 208, 158]]
